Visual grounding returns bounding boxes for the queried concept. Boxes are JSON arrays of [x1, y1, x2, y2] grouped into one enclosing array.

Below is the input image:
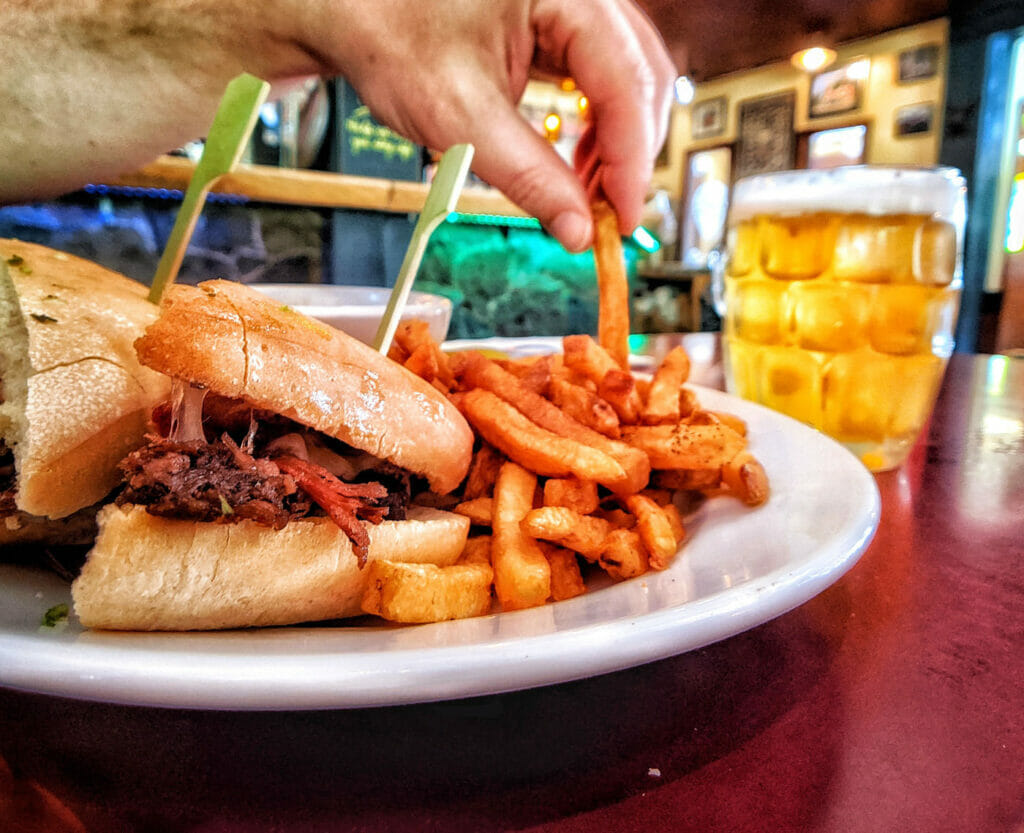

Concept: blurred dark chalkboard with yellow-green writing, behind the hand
[[332, 79, 423, 181]]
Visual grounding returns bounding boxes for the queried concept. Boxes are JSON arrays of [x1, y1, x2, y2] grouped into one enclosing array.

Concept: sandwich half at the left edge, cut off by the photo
[[0, 240, 169, 546]]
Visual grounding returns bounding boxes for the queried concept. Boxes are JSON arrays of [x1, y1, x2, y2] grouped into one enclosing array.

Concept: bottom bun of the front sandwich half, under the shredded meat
[[72, 505, 469, 630]]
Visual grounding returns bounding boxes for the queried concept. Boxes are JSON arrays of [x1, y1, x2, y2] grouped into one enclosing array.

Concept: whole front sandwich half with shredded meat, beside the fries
[[72, 281, 473, 630]]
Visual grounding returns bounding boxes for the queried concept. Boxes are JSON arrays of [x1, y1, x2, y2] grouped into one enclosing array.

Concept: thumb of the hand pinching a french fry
[[470, 100, 593, 252]]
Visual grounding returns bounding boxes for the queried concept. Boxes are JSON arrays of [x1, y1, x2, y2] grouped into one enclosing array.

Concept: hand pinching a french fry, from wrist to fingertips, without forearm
[[307, 0, 676, 251]]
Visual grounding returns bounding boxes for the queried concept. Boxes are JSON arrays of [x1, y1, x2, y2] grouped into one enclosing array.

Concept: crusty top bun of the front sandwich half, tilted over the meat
[[135, 281, 473, 494]]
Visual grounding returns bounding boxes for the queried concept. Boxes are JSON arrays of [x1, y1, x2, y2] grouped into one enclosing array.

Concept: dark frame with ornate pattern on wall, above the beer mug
[[733, 90, 797, 179]]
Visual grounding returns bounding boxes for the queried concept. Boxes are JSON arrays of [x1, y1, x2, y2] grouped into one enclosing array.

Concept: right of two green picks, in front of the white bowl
[[374, 144, 473, 353]]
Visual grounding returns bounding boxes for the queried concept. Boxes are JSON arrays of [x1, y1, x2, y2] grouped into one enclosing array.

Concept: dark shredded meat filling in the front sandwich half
[[117, 394, 412, 565]]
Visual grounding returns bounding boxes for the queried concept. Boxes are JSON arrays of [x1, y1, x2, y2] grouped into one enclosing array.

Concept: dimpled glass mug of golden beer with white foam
[[716, 165, 967, 471]]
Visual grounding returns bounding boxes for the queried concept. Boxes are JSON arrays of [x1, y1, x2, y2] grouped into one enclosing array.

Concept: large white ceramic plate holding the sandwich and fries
[[0, 388, 880, 709]]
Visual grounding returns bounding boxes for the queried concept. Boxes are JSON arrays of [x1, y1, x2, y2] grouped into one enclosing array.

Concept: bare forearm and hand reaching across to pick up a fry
[[0, 0, 676, 251]]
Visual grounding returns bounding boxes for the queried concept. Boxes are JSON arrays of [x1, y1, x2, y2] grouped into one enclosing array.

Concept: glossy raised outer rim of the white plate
[[0, 385, 881, 710]]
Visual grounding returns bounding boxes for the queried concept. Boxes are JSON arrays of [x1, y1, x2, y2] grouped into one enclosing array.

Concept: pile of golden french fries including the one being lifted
[[362, 201, 768, 622]]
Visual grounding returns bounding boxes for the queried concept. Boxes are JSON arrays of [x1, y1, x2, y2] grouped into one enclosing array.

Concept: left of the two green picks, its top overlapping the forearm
[[150, 73, 270, 303]]
